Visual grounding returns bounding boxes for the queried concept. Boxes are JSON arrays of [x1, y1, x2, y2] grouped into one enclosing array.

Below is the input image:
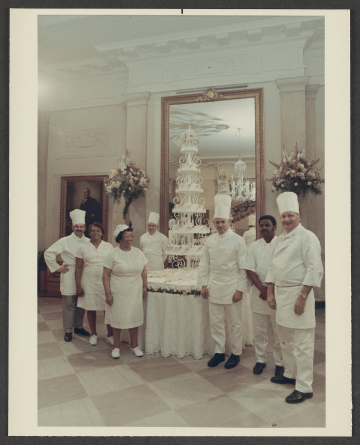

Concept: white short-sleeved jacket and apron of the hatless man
[[244, 236, 277, 315]]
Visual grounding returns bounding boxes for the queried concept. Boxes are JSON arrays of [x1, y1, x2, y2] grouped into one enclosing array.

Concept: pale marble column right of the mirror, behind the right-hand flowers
[[275, 76, 310, 227]]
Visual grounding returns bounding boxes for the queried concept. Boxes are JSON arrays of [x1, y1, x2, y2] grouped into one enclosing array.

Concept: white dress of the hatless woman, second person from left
[[76, 241, 114, 311]]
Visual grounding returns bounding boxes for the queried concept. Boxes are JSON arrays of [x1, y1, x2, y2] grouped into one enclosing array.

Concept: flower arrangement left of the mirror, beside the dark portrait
[[105, 150, 150, 219]]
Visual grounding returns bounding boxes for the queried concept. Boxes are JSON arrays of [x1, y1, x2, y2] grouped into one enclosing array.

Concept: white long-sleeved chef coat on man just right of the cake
[[198, 229, 251, 304]]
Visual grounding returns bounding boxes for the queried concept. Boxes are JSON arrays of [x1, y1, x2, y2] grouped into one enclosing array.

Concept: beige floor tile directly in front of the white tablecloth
[[127, 357, 191, 382]]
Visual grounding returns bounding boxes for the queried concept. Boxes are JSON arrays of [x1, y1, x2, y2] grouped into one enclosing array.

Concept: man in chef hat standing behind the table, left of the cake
[[140, 212, 169, 271]]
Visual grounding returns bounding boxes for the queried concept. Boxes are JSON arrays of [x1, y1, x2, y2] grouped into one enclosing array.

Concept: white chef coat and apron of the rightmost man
[[266, 224, 323, 329]]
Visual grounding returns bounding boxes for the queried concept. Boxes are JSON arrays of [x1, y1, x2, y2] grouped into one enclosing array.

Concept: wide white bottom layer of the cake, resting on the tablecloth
[[148, 269, 200, 292]]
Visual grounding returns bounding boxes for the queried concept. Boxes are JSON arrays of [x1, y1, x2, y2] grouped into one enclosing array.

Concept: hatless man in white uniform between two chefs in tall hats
[[244, 215, 284, 376]]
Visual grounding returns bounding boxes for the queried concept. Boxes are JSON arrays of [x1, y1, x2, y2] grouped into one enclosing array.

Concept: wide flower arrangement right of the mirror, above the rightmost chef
[[267, 144, 325, 196]]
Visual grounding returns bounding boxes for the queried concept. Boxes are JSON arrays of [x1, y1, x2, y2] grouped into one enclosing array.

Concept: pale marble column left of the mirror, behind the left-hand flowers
[[124, 92, 151, 247]]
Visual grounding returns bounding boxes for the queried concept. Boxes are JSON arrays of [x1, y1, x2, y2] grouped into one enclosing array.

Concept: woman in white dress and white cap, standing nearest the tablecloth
[[103, 223, 148, 358]]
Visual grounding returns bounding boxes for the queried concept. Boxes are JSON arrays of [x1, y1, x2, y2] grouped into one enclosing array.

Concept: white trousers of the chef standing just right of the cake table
[[209, 301, 242, 355]]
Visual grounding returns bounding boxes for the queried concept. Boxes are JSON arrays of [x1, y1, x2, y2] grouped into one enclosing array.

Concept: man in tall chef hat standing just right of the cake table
[[198, 195, 250, 369]]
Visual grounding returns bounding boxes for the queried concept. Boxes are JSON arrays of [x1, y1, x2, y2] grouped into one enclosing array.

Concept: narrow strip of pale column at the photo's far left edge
[[38, 111, 51, 250]]
